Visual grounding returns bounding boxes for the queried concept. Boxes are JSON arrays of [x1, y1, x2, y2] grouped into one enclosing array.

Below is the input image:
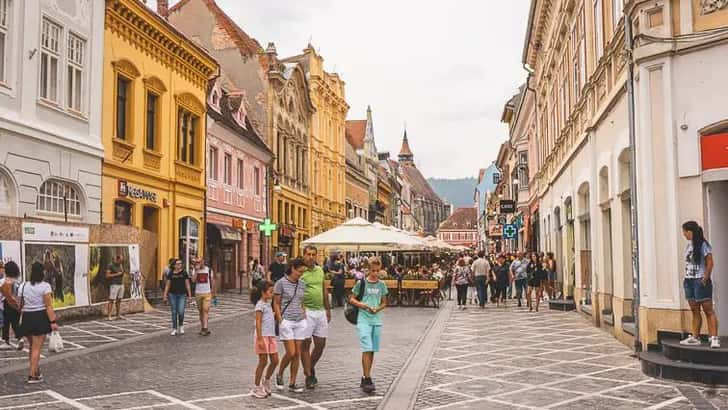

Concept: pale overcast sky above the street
[[158, 0, 530, 178]]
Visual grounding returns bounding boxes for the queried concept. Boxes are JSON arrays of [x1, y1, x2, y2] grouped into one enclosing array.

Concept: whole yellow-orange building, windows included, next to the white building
[[102, 0, 217, 283]]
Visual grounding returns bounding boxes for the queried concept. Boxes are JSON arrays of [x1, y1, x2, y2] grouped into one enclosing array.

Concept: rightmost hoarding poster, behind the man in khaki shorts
[[88, 245, 142, 303]]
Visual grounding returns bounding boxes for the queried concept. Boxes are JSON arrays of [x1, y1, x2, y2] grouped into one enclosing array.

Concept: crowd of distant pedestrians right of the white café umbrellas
[[450, 251, 556, 312]]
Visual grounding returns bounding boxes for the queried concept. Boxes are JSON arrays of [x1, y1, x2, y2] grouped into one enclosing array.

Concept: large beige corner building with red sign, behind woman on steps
[[523, 0, 728, 345]]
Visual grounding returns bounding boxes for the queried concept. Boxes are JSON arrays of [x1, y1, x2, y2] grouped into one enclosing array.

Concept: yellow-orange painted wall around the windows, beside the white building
[[102, 0, 217, 277]]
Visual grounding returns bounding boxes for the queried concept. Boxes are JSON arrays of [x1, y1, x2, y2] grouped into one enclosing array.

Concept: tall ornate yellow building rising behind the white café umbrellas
[[284, 44, 349, 235]]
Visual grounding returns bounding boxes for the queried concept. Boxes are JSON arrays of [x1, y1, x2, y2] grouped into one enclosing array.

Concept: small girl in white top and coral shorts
[[250, 280, 278, 399]]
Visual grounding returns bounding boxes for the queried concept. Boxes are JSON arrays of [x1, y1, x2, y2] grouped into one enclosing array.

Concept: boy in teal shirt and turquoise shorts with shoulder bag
[[349, 256, 389, 393]]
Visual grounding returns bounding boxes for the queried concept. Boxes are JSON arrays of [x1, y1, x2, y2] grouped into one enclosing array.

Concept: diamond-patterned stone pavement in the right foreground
[[415, 306, 728, 410]]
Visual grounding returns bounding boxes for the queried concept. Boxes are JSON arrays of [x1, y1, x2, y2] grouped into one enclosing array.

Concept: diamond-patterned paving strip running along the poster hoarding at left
[[0, 293, 253, 374]]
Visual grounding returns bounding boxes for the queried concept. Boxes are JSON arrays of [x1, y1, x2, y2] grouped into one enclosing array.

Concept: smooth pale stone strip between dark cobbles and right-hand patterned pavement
[[377, 302, 454, 410]]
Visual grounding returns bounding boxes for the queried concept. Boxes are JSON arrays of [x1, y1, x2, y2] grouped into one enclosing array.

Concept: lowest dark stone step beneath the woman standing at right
[[639, 352, 728, 385]]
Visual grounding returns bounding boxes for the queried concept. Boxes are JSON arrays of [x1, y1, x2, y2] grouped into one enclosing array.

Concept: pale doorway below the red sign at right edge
[[706, 181, 728, 335]]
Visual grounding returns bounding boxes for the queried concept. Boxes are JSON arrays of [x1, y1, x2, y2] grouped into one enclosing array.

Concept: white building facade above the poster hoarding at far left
[[0, 0, 104, 223]]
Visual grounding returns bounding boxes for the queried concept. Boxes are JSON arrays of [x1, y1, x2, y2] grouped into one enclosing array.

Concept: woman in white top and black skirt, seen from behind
[[18, 262, 58, 384]]
